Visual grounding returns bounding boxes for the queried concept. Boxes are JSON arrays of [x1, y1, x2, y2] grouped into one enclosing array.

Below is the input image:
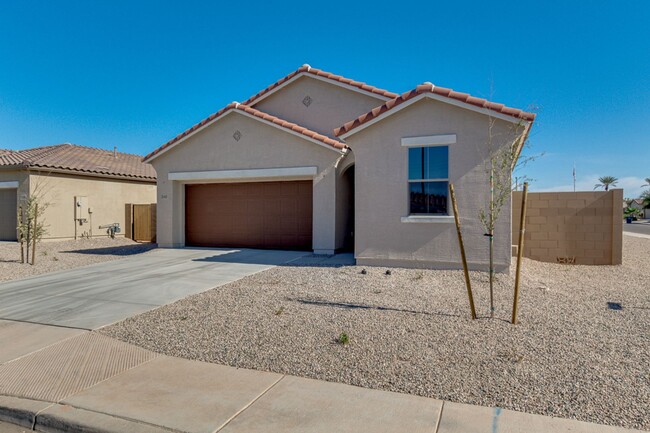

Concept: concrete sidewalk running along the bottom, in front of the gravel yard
[[0, 324, 632, 433]]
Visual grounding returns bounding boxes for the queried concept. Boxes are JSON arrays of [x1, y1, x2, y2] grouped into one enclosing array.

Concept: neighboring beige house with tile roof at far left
[[0, 144, 156, 240]]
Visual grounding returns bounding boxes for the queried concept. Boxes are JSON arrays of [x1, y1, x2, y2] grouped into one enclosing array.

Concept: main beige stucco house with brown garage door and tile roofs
[[144, 65, 535, 270]]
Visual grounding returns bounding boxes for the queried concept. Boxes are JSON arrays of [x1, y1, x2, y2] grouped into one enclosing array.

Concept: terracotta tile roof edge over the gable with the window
[[334, 83, 535, 137]]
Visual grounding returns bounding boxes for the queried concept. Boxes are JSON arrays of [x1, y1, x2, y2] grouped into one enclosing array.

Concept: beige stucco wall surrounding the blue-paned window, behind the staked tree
[[346, 99, 515, 271]]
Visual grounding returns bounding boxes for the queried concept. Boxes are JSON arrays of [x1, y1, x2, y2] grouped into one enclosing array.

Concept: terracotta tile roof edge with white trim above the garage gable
[[142, 102, 347, 161]]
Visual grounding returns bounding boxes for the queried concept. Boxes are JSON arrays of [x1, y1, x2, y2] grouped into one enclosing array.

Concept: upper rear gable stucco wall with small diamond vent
[[254, 75, 385, 136]]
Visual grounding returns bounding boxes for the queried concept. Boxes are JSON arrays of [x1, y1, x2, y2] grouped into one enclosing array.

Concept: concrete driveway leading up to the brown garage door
[[0, 248, 306, 329]]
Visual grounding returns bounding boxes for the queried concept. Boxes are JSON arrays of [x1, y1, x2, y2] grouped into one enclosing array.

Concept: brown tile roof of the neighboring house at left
[[0, 143, 156, 180]]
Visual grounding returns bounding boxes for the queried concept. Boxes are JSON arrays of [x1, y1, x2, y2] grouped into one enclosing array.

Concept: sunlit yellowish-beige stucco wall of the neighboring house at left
[[29, 172, 156, 239]]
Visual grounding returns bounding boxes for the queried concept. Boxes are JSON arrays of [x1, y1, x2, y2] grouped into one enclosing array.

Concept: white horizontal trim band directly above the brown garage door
[[167, 166, 318, 182]]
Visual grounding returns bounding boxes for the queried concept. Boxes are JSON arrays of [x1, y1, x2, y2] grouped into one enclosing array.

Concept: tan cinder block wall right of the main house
[[512, 189, 623, 265]]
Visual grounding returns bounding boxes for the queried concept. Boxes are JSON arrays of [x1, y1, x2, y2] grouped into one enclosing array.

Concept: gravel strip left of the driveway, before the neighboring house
[[0, 237, 156, 281]]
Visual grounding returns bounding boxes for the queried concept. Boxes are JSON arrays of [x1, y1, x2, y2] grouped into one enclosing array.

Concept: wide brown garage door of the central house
[[185, 180, 312, 250]]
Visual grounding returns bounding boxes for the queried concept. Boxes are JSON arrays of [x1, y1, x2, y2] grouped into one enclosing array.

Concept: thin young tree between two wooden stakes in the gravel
[[478, 117, 539, 317]]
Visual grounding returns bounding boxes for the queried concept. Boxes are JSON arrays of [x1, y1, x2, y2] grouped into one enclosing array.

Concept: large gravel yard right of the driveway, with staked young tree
[[100, 236, 650, 430]]
